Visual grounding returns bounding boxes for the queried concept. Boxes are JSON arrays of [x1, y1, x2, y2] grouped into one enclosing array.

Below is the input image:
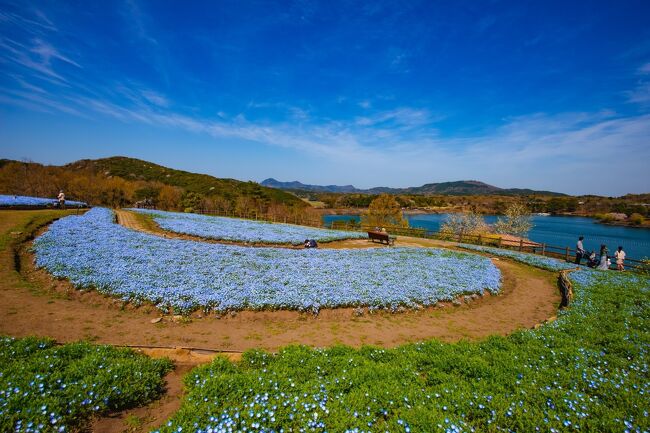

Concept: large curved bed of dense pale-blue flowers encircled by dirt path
[[34, 208, 500, 311]]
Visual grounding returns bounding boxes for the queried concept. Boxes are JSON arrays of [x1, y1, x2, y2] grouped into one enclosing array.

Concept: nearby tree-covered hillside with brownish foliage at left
[[0, 157, 306, 213]]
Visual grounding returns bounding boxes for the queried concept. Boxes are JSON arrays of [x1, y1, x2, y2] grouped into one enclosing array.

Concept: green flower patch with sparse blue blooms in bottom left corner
[[0, 337, 172, 433]]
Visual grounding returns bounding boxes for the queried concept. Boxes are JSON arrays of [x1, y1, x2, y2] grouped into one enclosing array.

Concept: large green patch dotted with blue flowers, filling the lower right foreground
[[151, 271, 650, 433]]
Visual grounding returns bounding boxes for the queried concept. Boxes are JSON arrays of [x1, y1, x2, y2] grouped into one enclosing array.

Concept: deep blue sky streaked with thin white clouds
[[0, 0, 650, 196]]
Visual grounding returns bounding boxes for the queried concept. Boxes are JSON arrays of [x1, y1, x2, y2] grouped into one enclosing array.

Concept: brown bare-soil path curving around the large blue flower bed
[[0, 211, 560, 433]]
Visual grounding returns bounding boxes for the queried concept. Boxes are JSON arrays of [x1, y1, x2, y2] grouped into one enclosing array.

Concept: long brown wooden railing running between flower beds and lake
[[195, 209, 650, 272]]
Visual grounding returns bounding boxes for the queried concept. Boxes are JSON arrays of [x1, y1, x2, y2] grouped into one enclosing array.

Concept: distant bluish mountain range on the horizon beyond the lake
[[261, 178, 566, 196]]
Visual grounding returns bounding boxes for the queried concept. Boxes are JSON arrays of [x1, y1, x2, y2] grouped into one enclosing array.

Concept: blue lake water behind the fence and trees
[[323, 214, 650, 259]]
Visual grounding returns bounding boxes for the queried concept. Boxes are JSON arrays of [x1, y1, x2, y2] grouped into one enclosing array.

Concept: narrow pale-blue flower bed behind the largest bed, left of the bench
[[131, 209, 367, 245]]
